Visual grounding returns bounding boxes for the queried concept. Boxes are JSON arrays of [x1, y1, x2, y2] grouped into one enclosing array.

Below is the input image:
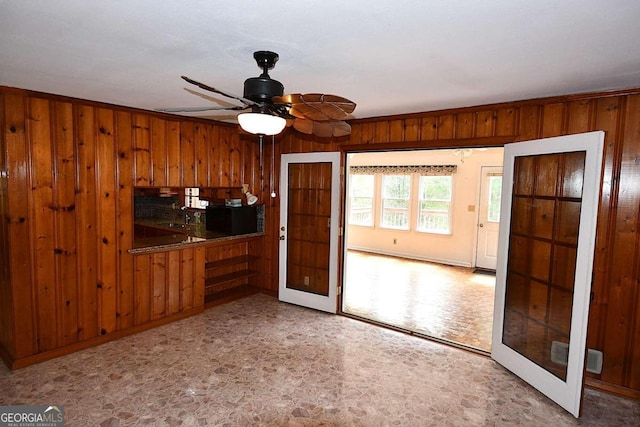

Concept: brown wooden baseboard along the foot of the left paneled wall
[[0, 306, 204, 370]]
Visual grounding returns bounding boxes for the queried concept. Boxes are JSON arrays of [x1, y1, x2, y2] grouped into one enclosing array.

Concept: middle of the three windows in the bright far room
[[380, 175, 411, 230]]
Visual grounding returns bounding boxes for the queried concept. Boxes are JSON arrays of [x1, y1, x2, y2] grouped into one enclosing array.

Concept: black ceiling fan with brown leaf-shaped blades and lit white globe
[[158, 50, 356, 137]]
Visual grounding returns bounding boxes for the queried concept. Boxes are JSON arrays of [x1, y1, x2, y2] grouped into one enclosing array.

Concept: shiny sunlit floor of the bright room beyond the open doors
[[342, 250, 495, 352]]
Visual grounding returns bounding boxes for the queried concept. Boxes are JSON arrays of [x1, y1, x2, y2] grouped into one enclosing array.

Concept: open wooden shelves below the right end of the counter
[[204, 236, 263, 304]]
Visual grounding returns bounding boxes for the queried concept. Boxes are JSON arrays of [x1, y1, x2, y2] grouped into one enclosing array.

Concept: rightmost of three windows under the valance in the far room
[[418, 175, 453, 234]]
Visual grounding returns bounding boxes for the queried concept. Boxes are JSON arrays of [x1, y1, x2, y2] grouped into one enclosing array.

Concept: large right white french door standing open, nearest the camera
[[491, 132, 604, 417]]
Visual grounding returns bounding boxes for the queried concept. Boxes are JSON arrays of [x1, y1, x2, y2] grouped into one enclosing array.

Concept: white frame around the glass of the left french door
[[278, 152, 341, 313]]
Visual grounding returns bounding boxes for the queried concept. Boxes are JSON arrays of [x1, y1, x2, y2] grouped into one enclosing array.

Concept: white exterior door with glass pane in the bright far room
[[475, 166, 502, 270]]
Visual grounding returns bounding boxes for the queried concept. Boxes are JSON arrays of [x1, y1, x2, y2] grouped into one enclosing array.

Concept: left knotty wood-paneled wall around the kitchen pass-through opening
[[0, 88, 264, 366]]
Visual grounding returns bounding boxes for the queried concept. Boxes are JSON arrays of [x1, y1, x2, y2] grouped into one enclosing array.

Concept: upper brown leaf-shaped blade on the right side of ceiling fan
[[272, 93, 356, 121]]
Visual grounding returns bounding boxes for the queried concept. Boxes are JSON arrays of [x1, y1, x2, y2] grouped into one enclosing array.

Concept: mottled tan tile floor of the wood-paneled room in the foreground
[[0, 294, 640, 427]]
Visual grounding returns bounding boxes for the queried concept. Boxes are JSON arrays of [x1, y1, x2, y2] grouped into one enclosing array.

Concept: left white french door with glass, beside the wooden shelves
[[278, 152, 340, 313]]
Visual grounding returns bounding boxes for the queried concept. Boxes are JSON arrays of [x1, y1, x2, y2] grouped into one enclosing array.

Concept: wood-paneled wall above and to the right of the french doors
[[274, 89, 640, 398]]
